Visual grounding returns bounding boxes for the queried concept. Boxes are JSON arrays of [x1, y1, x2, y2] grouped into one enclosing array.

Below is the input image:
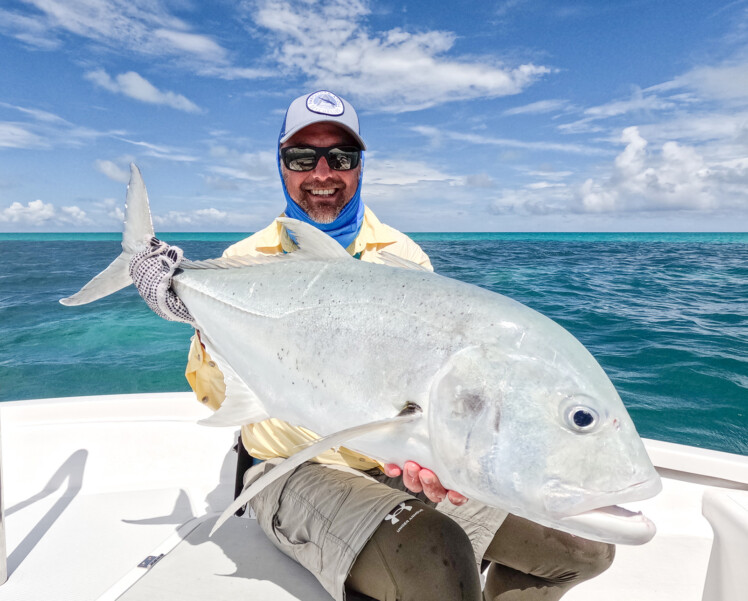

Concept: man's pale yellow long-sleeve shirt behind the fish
[[185, 207, 433, 470]]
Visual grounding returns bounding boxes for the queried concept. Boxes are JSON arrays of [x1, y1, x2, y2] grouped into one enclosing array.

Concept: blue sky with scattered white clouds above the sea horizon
[[0, 0, 748, 232]]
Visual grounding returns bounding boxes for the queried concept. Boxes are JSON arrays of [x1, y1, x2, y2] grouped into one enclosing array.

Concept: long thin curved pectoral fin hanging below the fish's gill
[[210, 403, 422, 536]]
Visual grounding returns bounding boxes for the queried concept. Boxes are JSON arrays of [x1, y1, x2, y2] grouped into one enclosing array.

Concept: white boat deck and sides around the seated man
[[0, 393, 748, 601]]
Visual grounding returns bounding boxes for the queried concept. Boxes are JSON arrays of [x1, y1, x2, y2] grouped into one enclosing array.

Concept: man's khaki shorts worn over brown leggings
[[244, 459, 507, 601]]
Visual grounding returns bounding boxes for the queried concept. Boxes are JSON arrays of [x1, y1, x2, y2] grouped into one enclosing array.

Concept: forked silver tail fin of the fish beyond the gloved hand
[[60, 163, 154, 306]]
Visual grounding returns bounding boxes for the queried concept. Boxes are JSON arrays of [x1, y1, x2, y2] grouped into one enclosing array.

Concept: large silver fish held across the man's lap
[[61, 165, 661, 544]]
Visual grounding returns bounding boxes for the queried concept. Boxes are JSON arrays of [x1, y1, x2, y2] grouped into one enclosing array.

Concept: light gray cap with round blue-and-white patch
[[278, 90, 366, 150]]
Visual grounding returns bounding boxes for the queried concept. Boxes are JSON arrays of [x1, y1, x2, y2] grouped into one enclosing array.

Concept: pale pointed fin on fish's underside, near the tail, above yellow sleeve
[[198, 334, 270, 426]]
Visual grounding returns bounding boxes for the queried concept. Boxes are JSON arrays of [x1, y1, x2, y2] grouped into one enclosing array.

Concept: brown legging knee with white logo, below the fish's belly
[[346, 500, 481, 601]]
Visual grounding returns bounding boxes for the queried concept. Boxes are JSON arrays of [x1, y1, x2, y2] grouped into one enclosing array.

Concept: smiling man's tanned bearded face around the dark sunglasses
[[281, 123, 361, 223]]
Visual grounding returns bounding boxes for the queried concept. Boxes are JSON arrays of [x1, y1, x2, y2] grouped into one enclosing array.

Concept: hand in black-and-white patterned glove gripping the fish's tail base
[[130, 238, 194, 325]]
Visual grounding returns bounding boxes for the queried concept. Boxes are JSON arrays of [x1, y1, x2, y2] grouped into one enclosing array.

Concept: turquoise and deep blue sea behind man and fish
[[0, 233, 748, 455]]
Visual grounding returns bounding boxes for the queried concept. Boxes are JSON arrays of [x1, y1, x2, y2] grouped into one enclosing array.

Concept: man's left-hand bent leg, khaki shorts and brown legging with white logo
[[245, 461, 481, 601]]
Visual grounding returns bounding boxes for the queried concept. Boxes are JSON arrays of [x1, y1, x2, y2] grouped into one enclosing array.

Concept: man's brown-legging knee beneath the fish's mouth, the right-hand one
[[484, 514, 615, 601]]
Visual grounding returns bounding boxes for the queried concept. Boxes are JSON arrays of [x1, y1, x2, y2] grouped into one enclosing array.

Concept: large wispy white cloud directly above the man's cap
[[253, 0, 551, 112]]
